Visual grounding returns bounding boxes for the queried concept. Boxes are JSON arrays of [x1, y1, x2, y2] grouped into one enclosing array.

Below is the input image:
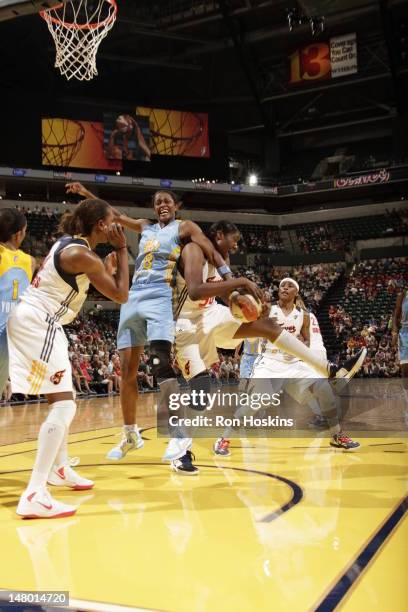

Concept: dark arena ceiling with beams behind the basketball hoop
[[0, 0, 408, 179]]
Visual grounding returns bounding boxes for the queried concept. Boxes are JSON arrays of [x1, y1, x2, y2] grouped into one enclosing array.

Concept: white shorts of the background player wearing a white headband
[[251, 355, 321, 403]]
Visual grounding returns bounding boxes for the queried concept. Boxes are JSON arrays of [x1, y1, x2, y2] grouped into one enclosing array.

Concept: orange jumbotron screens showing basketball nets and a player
[[42, 106, 210, 170]]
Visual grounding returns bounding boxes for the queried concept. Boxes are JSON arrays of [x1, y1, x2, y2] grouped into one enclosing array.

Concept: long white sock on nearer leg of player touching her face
[[27, 400, 76, 491]]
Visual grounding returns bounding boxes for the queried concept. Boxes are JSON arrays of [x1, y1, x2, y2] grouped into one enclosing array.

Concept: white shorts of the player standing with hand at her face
[[7, 303, 73, 395]]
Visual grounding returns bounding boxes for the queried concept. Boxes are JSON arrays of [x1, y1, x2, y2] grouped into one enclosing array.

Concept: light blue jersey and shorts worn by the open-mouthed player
[[117, 221, 181, 349]]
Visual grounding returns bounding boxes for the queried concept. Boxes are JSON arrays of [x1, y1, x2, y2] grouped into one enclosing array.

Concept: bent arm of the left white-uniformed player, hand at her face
[[60, 223, 129, 304]]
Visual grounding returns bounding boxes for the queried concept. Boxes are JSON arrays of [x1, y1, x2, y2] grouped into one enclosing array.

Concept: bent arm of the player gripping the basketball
[[181, 242, 263, 302]]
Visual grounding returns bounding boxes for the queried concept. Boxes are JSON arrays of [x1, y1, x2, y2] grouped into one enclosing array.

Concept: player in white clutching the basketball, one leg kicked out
[[171, 221, 364, 474]]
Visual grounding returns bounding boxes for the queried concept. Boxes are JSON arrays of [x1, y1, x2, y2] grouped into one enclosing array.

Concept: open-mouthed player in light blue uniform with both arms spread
[[63, 183, 261, 461]]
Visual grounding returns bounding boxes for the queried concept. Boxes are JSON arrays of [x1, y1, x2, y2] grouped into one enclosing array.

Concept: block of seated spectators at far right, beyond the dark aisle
[[329, 257, 408, 378]]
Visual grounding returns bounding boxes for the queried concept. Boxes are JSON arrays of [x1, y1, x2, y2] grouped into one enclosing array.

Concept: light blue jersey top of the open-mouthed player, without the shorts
[[132, 220, 180, 289]]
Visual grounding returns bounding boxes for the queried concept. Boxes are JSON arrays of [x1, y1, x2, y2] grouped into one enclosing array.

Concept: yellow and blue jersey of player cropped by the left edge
[[0, 245, 32, 330]]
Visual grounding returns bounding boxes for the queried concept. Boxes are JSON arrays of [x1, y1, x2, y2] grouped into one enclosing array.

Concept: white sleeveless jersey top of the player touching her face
[[21, 236, 91, 325]]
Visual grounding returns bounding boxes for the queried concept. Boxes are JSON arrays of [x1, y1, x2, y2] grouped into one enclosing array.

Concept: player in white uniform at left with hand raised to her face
[[7, 199, 129, 518]]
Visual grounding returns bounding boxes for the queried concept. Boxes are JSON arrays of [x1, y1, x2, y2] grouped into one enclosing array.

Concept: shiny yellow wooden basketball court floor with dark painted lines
[[0, 394, 408, 612]]
